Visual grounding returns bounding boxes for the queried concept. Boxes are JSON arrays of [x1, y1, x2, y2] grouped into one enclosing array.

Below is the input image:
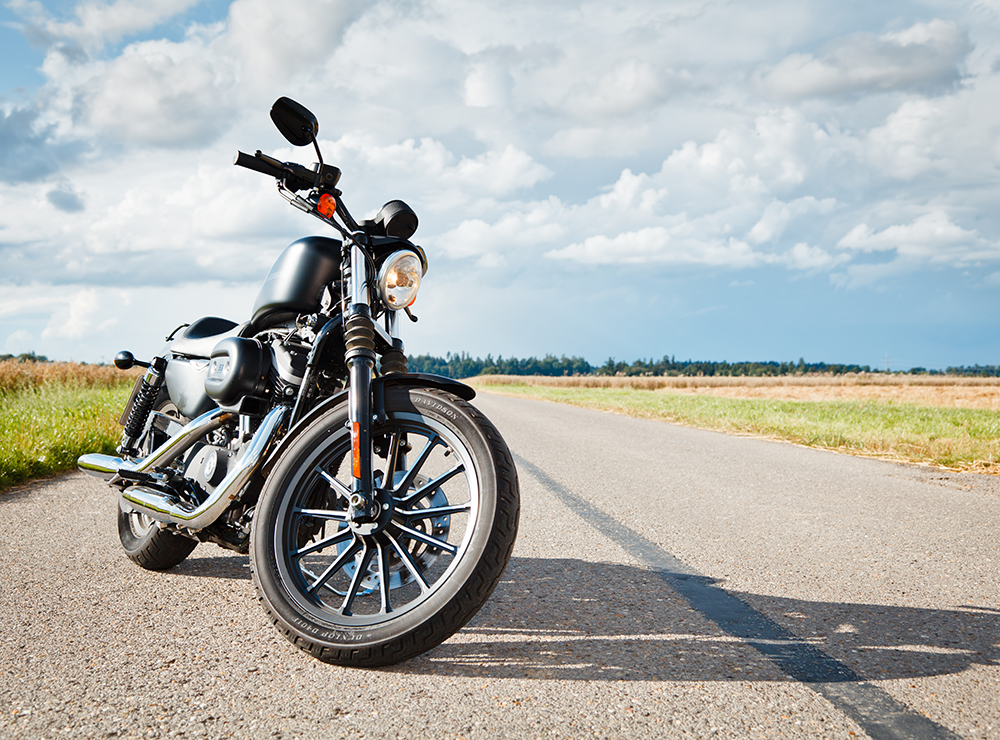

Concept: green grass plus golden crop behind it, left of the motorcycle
[[0, 361, 135, 491]]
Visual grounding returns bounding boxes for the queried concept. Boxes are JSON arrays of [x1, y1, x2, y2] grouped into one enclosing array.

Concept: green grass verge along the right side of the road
[[476, 383, 1000, 474]]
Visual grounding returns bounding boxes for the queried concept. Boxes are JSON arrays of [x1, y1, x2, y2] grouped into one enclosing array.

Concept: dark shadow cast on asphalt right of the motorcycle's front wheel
[[388, 558, 1000, 681]]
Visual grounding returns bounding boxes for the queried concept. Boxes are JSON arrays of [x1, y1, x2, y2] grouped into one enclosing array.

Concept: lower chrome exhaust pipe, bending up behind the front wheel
[[120, 406, 289, 530]]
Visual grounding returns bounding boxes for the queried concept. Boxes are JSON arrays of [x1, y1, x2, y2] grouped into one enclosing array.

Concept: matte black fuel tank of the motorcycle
[[251, 236, 341, 330]]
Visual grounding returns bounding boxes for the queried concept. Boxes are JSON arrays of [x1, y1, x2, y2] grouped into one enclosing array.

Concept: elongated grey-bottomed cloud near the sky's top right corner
[[755, 19, 972, 99]]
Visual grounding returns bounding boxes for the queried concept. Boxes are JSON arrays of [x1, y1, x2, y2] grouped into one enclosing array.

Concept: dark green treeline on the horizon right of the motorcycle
[[407, 352, 1000, 378]]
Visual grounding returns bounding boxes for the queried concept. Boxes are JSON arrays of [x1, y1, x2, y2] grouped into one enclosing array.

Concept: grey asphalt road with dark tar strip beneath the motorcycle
[[0, 395, 1000, 740]]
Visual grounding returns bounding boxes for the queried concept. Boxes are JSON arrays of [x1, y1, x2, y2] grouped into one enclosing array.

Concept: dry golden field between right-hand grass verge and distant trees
[[475, 374, 1000, 411]]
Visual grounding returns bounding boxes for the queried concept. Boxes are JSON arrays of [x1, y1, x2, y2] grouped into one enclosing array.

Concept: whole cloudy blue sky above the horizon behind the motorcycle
[[0, 0, 1000, 370]]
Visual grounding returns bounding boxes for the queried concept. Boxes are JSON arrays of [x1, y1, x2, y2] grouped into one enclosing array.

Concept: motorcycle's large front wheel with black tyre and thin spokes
[[250, 388, 520, 666]]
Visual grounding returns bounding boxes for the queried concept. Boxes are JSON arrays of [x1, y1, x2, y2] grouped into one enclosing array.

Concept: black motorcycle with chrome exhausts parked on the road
[[78, 98, 520, 666]]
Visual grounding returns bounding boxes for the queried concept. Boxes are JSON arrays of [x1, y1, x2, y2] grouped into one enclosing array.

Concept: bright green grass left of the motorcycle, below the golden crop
[[0, 377, 133, 491]]
